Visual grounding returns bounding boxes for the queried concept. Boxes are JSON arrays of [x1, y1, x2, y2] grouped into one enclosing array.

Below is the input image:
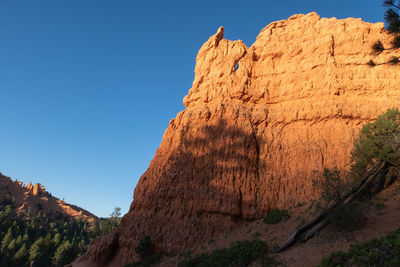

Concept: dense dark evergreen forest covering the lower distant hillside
[[0, 195, 119, 267]]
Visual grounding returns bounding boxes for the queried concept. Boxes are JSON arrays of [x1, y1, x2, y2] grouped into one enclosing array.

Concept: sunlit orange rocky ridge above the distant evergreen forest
[[0, 173, 99, 225]]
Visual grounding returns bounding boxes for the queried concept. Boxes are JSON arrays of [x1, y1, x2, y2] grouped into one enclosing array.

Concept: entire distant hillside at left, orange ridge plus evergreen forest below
[[0, 174, 120, 267]]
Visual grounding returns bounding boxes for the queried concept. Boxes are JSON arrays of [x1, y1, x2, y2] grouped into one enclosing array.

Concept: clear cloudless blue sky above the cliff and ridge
[[0, 0, 383, 217]]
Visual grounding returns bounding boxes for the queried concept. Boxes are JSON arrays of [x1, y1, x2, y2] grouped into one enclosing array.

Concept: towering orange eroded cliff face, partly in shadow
[[76, 13, 400, 266]]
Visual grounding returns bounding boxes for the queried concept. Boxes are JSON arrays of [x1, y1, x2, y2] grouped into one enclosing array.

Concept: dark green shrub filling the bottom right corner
[[318, 228, 400, 267]]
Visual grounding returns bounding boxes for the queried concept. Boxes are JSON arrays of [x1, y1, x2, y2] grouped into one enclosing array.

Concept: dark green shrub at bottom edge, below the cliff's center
[[178, 239, 278, 267]]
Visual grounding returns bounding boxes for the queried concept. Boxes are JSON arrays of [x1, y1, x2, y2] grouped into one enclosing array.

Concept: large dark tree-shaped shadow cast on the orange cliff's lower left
[[126, 120, 259, 252]]
